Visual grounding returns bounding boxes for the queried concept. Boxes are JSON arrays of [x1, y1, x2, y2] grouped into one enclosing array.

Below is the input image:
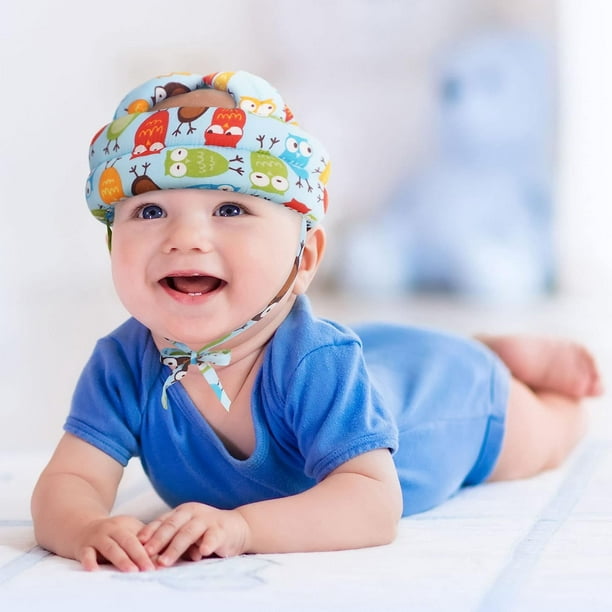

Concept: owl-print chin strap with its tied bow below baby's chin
[[160, 218, 307, 412]]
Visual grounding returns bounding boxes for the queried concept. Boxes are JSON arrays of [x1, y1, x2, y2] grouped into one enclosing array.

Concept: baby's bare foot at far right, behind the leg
[[477, 335, 603, 398]]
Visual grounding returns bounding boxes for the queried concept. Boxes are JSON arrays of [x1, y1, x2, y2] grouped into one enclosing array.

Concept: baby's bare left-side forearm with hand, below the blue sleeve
[[32, 434, 154, 571]]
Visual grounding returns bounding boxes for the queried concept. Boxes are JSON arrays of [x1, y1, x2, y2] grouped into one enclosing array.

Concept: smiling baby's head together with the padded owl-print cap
[[87, 72, 330, 363]]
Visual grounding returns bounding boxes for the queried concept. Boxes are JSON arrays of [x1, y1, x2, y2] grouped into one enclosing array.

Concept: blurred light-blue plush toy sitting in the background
[[341, 32, 555, 302]]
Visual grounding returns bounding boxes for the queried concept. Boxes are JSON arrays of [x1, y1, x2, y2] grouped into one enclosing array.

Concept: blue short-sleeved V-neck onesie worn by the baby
[[65, 296, 509, 516]]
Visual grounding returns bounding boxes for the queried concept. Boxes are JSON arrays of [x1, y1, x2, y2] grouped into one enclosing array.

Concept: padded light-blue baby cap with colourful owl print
[[86, 72, 330, 227]]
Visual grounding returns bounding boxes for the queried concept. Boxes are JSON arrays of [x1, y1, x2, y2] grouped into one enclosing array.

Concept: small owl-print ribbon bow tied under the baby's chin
[[160, 342, 232, 412]]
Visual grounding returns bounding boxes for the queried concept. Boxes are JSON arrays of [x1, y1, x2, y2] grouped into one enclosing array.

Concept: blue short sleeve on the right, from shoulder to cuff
[[264, 304, 398, 481]]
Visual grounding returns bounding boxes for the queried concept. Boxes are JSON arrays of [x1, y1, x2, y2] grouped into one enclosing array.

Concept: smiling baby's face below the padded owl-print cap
[[111, 189, 301, 349]]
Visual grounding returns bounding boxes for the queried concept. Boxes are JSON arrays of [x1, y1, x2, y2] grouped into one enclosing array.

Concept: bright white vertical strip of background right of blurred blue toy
[[559, 0, 612, 296]]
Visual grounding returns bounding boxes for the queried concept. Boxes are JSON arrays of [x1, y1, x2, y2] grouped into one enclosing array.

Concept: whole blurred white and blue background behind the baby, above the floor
[[0, 0, 612, 449]]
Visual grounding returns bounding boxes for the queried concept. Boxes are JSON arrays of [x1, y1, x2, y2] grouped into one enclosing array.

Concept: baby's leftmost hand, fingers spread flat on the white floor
[[75, 516, 155, 572]]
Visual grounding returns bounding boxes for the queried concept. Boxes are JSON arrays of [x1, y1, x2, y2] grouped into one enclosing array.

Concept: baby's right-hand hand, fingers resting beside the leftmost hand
[[138, 502, 249, 567]]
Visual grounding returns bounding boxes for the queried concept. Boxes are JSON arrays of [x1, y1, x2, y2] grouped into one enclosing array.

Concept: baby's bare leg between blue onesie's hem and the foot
[[488, 379, 586, 481]]
